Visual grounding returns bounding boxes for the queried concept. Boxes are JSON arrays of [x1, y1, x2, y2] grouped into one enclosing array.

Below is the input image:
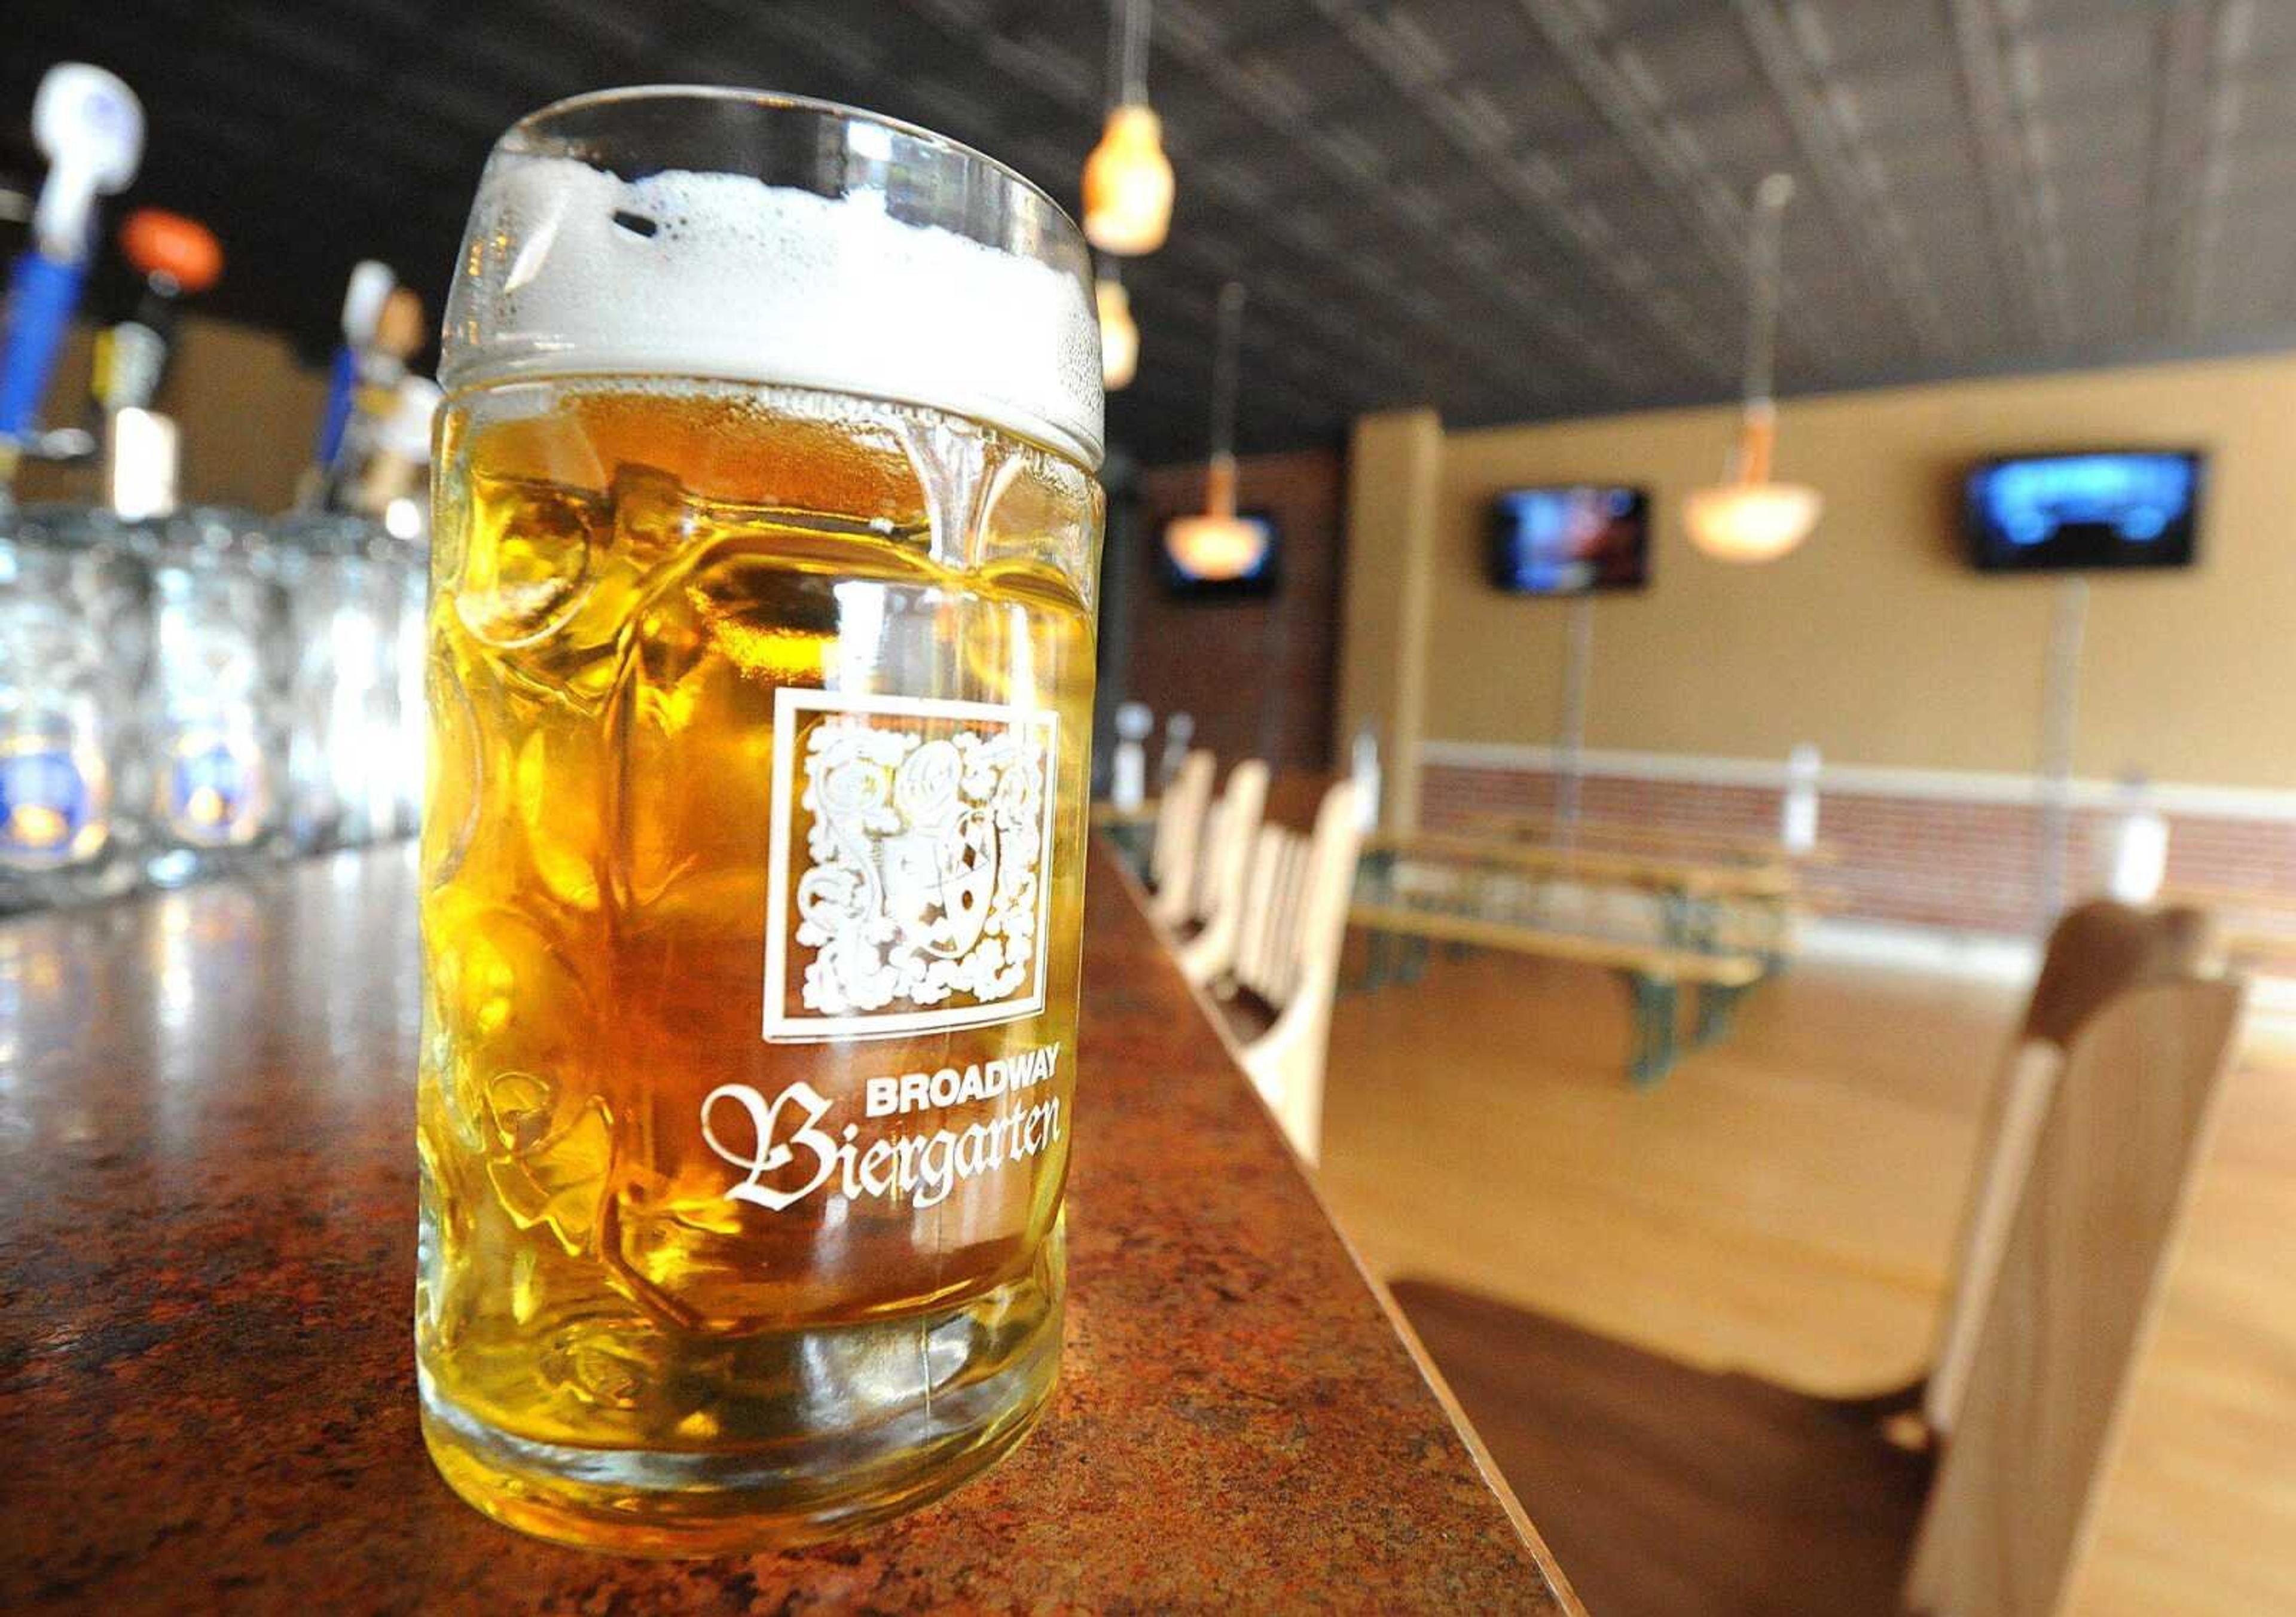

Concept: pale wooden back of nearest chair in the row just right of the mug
[[1228, 781, 1361, 1162]]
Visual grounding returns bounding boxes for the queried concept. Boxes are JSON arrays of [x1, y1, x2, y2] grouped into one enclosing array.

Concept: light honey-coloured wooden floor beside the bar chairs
[[1323, 955, 2296, 1617]]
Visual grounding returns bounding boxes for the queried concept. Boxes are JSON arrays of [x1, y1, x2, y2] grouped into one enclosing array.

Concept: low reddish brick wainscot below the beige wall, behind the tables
[[1419, 765, 2296, 935]]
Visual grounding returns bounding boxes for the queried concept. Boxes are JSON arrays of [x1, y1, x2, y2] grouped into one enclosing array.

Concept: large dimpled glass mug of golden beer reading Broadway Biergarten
[[416, 90, 1102, 1555]]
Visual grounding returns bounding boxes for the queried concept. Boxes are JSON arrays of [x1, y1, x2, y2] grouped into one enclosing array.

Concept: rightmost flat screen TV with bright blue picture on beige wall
[[1963, 450, 2206, 572]]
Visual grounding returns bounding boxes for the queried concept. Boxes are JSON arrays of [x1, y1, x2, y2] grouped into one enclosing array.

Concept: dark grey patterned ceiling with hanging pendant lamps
[[0, 0, 2296, 461]]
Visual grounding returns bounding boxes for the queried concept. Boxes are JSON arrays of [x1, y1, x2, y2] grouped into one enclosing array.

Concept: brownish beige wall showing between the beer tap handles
[[19, 314, 326, 512]]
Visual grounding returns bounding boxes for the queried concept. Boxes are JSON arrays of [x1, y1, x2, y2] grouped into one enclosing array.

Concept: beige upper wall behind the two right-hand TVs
[[1423, 356, 2296, 788]]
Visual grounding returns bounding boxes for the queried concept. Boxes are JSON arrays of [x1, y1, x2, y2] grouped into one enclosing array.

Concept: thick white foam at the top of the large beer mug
[[441, 154, 1102, 464]]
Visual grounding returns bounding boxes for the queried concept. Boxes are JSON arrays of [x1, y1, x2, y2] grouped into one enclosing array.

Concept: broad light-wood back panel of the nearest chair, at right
[[1906, 976, 2241, 1617]]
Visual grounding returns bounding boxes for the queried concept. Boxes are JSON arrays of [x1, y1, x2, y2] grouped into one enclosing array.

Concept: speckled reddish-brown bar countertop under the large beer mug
[[0, 850, 1577, 1612]]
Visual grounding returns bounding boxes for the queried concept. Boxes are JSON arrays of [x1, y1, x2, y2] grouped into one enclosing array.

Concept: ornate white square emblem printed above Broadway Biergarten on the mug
[[765, 689, 1058, 1043]]
